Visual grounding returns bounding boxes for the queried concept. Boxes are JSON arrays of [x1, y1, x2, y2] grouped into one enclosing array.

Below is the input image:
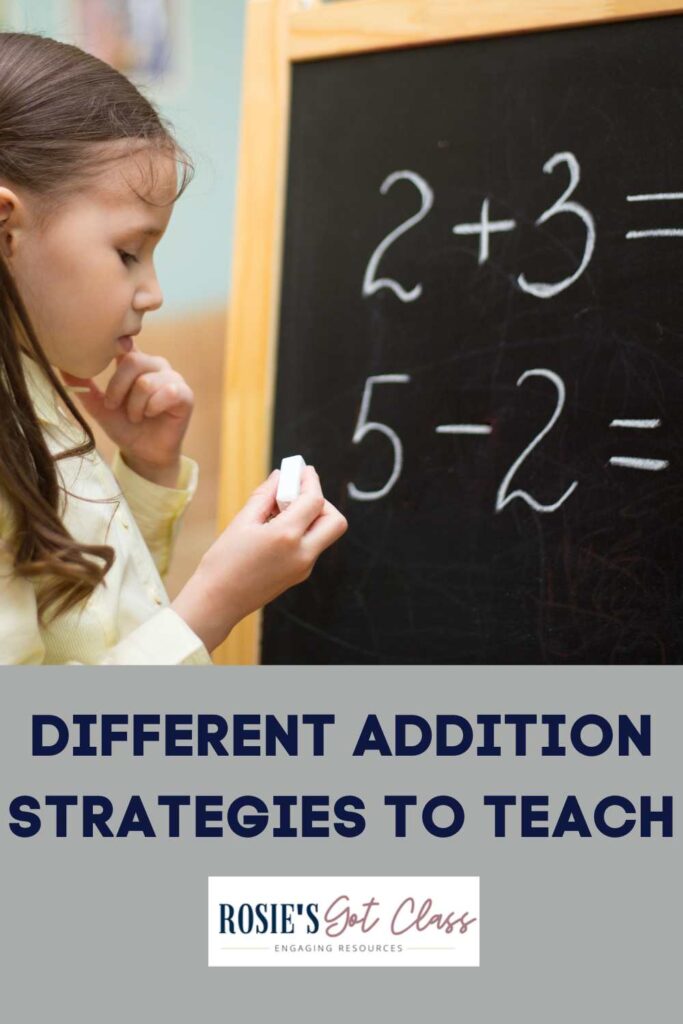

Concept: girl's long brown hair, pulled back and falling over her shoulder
[[0, 32, 194, 621]]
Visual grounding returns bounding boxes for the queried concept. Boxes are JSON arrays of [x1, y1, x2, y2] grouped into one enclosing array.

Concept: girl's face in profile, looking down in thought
[[0, 143, 177, 378]]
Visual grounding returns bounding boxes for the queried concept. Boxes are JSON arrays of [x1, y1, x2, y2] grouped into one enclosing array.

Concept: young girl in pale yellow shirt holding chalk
[[0, 33, 346, 665]]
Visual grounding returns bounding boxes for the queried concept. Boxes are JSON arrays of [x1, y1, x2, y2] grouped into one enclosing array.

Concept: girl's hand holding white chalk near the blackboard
[[172, 466, 347, 650]]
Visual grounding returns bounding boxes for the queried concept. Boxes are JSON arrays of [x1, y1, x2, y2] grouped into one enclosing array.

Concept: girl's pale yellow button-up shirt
[[0, 355, 212, 665]]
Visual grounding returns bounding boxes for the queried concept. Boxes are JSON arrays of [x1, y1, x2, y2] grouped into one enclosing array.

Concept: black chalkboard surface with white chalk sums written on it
[[261, 16, 683, 664]]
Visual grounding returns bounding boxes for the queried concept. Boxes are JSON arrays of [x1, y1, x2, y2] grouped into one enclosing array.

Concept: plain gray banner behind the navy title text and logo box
[[0, 667, 683, 1024]]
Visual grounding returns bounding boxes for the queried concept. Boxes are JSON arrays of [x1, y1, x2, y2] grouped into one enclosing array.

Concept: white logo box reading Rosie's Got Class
[[208, 876, 480, 968]]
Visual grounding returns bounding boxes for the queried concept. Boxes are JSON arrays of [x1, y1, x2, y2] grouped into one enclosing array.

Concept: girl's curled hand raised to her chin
[[61, 345, 195, 487]]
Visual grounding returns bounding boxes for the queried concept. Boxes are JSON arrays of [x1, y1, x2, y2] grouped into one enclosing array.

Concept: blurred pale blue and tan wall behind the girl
[[0, 0, 246, 596]]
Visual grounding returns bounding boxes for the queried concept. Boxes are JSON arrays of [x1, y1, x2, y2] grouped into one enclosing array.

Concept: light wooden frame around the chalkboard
[[215, 0, 683, 665]]
